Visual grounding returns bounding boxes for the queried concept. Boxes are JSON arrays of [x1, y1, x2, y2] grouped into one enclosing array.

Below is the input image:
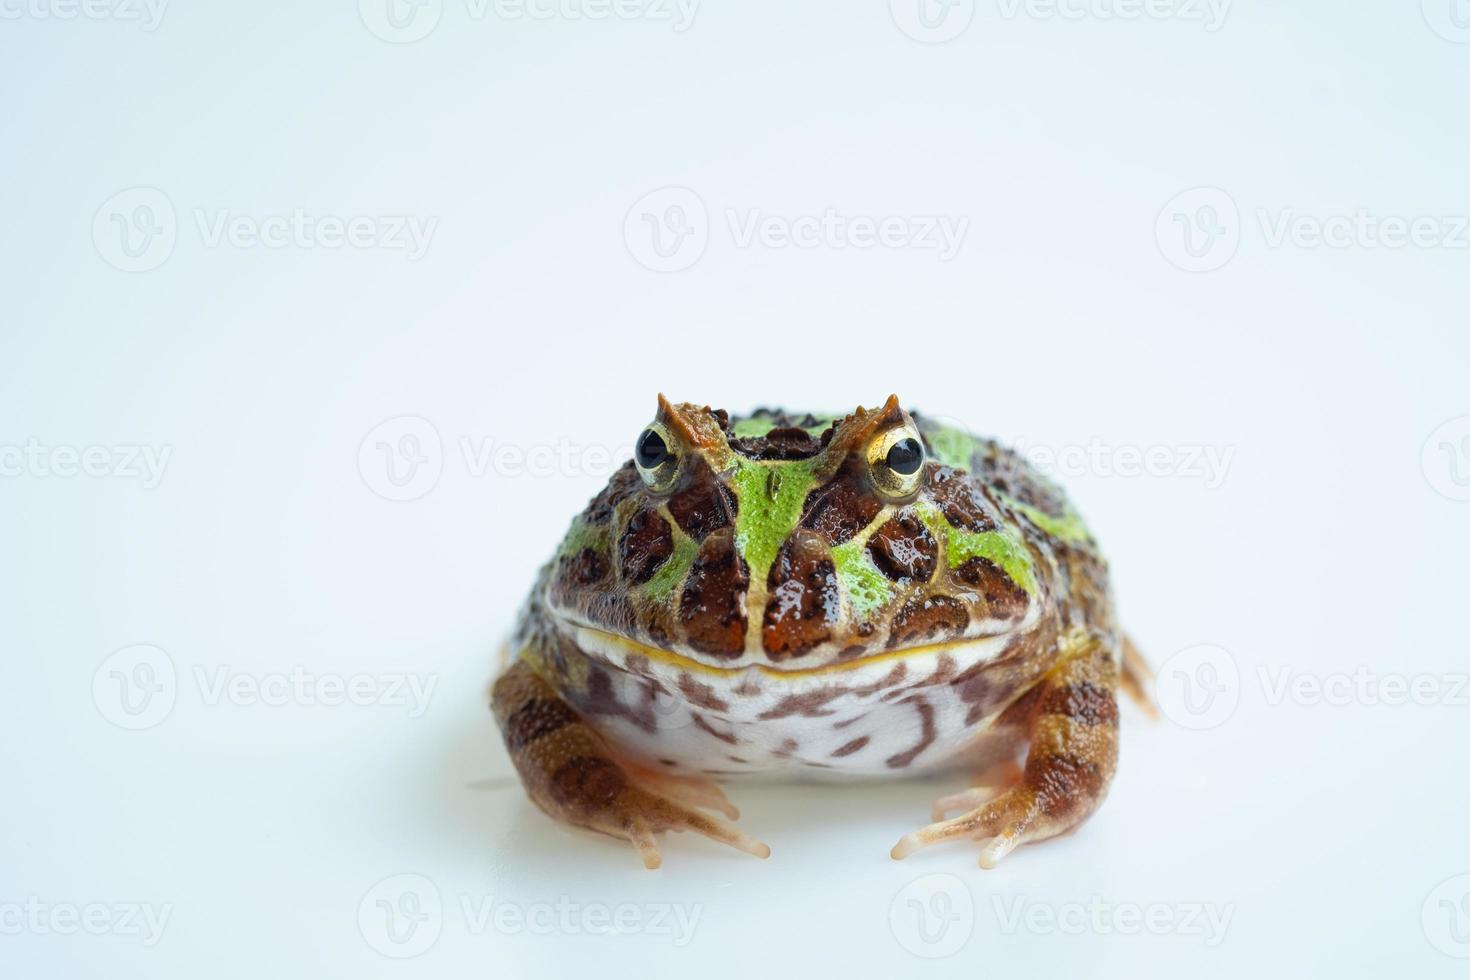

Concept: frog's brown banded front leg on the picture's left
[[491, 661, 770, 868]]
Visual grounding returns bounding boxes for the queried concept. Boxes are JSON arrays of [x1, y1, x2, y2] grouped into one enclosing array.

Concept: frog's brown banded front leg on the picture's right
[[892, 639, 1117, 868]]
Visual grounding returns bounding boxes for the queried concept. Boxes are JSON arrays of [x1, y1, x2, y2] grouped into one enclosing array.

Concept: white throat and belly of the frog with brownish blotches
[[564, 629, 1026, 779]]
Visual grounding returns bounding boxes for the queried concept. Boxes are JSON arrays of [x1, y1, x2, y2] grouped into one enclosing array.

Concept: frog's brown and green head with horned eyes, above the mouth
[[548, 395, 1038, 670]]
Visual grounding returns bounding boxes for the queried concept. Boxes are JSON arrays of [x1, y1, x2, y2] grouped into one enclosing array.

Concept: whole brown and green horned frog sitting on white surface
[[490, 394, 1154, 868]]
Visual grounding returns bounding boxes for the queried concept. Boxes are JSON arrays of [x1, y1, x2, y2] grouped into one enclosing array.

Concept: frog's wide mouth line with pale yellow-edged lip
[[566, 623, 1016, 680]]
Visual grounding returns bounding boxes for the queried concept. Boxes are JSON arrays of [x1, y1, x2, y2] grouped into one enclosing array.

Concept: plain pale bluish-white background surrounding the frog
[[0, 0, 1470, 979]]
